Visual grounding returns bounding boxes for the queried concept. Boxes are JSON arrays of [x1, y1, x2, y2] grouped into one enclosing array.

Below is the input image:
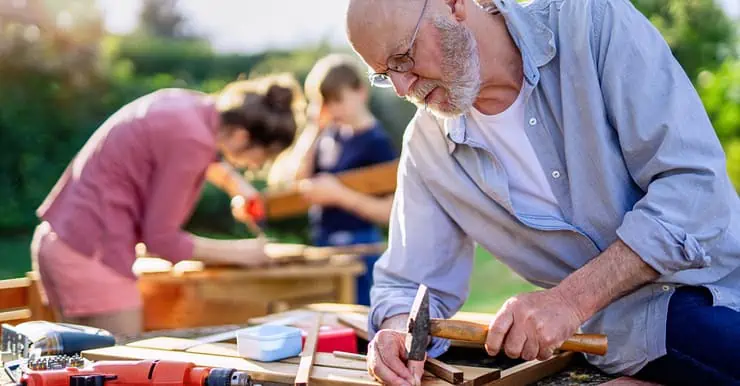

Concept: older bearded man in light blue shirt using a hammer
[[347, 0, 740, 384]]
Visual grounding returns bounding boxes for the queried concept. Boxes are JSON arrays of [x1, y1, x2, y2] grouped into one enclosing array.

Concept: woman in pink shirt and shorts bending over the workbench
[[31, 75, 302, 335]]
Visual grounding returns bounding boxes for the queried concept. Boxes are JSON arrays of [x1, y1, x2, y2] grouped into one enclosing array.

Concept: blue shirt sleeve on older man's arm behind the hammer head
[[368, 121, 474, 357]]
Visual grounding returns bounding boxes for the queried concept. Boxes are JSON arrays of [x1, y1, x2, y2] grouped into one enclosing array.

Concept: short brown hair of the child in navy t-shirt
[[304, 54, 365, 103]]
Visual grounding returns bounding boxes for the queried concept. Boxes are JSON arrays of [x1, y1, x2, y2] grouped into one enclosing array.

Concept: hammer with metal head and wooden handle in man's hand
[[405, 284, 607, 361]]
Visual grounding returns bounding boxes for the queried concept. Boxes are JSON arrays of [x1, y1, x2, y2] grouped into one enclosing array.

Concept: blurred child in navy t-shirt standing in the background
[[276, 54, 397, 305]]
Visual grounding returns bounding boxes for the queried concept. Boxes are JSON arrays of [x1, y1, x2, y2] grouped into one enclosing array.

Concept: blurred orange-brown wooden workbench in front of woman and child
[[134, 256, 365, 331]]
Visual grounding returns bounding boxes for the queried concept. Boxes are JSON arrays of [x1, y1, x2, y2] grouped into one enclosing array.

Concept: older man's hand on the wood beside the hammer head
[[367, 329, 424, 386]]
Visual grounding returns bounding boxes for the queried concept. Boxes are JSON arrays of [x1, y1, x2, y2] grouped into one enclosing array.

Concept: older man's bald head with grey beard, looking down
[[347, 0, 480, 116]]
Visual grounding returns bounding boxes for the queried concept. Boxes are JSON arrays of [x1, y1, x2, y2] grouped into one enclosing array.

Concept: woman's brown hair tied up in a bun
[[217, 73, 305, 148]]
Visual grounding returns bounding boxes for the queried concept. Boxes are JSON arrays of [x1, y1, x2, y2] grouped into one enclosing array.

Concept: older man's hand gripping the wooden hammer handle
[[485, 289, 583, 361]]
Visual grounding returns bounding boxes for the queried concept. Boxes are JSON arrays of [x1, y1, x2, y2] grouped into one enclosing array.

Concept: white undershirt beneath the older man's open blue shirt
[[466, 88, 562, 218]]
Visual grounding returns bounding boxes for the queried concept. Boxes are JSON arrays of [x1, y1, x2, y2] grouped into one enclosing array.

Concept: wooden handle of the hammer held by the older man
[[429, 319, 608, 355]]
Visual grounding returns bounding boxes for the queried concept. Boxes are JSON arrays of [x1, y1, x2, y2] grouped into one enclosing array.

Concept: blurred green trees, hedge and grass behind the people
[[0, 0, 740, 311]]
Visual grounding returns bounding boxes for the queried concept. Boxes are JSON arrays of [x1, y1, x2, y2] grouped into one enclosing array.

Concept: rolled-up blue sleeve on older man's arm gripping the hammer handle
[[593, 0, 740, 276]]
